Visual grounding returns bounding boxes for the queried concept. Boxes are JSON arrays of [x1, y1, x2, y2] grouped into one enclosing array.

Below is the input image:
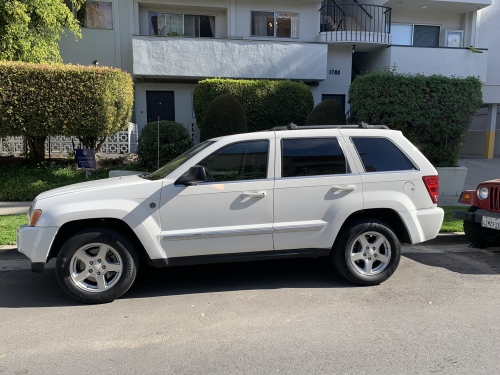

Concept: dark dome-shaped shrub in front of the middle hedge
[[200, 94, 247, 141]]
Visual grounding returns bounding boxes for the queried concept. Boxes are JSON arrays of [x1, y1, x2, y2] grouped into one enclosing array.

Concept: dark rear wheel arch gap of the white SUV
[[334, 208, 411, 250]]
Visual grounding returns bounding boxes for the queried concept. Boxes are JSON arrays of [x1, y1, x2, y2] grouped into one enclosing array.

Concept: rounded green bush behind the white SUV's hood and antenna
[[137, 121, 193, 171]]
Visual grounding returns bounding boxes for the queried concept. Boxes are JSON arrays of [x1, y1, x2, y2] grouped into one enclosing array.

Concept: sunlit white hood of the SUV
[[36, 175, 151, 200]]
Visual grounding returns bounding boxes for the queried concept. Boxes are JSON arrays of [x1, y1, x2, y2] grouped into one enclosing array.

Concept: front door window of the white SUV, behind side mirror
[[199, 140, 269, 182]]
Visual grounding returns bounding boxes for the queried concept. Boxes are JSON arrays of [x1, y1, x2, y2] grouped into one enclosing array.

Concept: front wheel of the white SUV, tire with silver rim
[[56, 228, 139, 304]]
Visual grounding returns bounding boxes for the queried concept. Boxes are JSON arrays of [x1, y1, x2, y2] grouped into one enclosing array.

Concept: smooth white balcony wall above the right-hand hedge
[[364, 45, 488, 82]]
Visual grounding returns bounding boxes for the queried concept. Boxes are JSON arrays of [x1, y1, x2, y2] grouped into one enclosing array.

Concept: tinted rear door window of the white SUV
[[281, 138, 346, 177]]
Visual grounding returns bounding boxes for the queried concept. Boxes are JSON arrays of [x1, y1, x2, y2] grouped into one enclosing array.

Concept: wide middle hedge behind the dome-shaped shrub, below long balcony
[[193, 78, 314, 132]]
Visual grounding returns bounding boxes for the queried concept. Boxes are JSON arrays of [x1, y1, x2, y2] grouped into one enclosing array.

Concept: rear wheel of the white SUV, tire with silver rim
[[332, 219, 401, 286]]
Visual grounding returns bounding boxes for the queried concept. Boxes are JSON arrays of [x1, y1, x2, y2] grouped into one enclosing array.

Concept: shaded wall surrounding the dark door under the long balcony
[[134, 83, 200, 132]]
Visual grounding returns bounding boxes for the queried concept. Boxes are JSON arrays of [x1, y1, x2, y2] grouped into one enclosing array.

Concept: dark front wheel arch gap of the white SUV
[[46, 218, 150, 262]]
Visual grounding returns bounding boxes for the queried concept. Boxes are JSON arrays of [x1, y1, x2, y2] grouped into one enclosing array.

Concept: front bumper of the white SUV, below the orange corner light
[[16, 225, 59, 272]]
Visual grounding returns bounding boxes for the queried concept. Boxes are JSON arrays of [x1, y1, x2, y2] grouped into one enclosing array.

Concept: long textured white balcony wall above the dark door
[[132, 36, 328, 82]]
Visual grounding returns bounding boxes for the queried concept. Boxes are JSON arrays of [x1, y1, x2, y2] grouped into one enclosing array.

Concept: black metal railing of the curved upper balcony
[[320, 0, 391, 43]]
